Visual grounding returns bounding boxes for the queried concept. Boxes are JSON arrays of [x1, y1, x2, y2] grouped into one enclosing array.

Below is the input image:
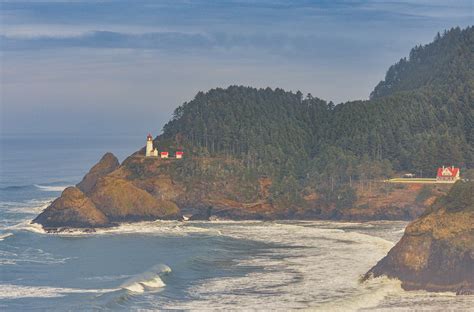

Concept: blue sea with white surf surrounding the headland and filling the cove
[[0, 136, 474, 311]]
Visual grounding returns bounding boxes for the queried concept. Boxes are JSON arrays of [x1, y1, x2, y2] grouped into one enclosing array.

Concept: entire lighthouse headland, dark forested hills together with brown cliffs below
[[34, 27, 474, 230]]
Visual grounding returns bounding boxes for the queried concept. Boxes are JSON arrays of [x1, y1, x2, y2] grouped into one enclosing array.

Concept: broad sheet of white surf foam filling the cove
[[163, 221, 406, 311]]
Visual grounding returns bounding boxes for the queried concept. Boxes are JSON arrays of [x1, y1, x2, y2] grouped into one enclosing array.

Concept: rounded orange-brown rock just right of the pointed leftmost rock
[[90, 176, 180, 221]]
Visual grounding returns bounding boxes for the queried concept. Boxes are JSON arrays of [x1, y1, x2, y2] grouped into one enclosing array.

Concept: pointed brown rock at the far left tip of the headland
[[33, 186, 109, 228]]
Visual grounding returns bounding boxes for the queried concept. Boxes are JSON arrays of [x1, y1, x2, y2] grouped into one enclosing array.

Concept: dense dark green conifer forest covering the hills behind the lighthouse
[[157, 27, 474, 207]]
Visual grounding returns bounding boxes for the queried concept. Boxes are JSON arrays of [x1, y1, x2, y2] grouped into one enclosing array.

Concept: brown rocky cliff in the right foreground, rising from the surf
[[366, 182, 474, 294]]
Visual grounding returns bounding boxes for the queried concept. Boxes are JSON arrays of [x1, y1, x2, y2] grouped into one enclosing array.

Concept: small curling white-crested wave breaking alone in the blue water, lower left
[[120, 264, 171, 293]]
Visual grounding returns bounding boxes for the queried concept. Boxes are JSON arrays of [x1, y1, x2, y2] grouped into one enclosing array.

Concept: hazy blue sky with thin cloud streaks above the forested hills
[[0, 0, 474, 135]]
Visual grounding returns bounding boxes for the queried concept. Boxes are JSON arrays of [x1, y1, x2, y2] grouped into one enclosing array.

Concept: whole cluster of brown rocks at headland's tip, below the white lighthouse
[[33, 153, 181, 230]]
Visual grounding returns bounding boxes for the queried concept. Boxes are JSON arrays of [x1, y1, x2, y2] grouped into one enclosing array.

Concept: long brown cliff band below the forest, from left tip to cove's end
[[33, 152, 446, 229]]
